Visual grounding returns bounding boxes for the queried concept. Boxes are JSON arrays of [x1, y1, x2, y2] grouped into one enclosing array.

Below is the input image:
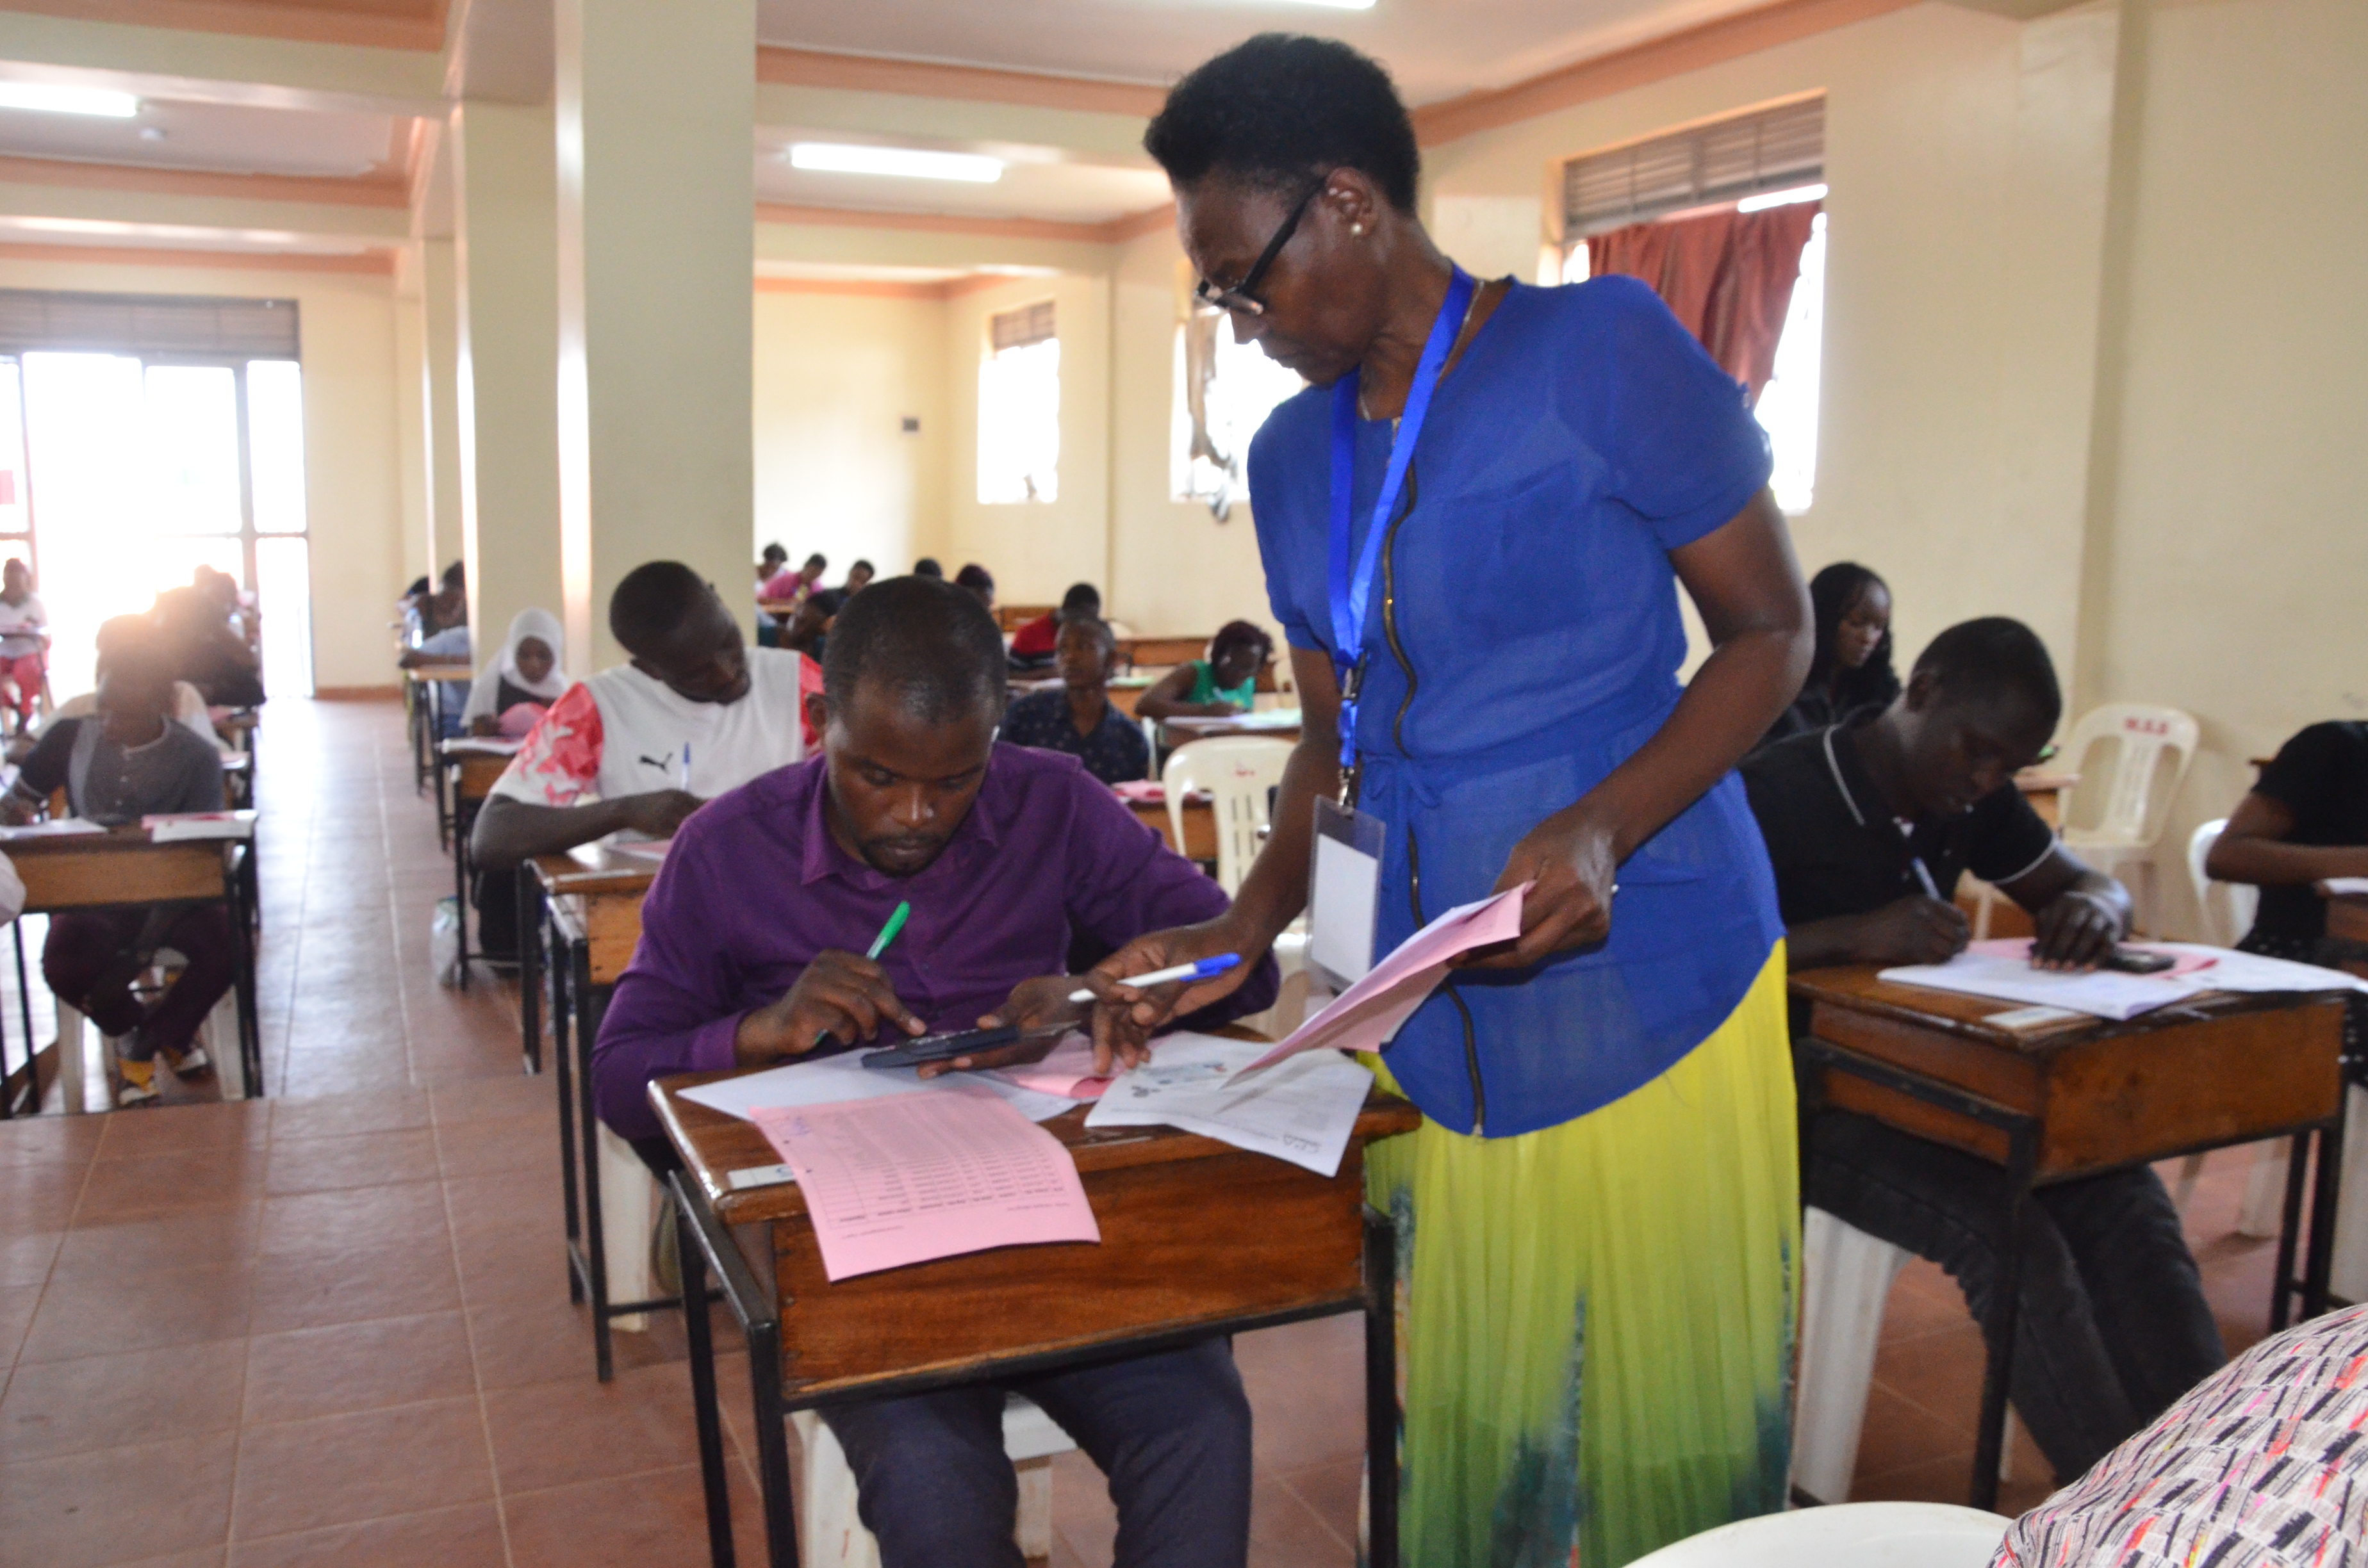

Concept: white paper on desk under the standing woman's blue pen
[[1085, 1033, 1374, 1177]]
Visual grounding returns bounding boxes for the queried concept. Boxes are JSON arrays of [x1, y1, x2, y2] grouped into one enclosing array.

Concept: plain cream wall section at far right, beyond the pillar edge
[[2084, 0, 2368, 933]]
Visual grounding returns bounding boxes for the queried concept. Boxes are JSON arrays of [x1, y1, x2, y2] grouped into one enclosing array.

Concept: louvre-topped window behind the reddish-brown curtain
[[1563, 97, 1826, 514]]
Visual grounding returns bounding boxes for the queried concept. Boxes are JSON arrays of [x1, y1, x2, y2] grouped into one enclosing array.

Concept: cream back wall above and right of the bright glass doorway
[[0, 256, 407, 687]]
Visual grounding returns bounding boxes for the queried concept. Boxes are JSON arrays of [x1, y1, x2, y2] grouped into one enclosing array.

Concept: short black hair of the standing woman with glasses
[[1144, 33, 1423, 213]]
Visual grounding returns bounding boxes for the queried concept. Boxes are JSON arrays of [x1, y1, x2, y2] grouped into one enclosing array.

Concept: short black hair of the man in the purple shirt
[[822, 573, 1004, 725]]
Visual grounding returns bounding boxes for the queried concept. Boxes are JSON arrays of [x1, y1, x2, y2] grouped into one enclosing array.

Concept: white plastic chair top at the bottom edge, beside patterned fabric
[[1629, 1501, 2013, 1568]]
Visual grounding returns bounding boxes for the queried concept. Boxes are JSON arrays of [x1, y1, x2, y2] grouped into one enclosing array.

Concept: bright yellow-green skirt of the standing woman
[[1367, 943, 1800, 1568]]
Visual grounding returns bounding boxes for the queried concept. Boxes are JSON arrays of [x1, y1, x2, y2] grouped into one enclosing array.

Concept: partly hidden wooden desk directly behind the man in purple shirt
[[518, 843, 677, 1384]]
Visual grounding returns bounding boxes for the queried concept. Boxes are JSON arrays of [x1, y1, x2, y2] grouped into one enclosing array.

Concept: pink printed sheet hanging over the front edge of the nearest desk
[[751, 1092, 1101, 1279]]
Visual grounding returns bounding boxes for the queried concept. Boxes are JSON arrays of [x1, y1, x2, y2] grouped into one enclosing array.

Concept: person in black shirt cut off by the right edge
[[2205, 720, 2368, 964]]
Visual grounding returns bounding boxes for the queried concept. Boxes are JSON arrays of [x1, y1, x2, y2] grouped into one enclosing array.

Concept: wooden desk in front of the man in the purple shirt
[[651, 1073, 1421, 1568]]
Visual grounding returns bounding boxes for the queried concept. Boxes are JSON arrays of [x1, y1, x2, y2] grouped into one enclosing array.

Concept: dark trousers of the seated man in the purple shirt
[[822, 1338, 1250, 1568]]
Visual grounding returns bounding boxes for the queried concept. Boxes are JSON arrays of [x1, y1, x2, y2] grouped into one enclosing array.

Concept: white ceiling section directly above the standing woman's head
[[755, 0, 1764, 104]]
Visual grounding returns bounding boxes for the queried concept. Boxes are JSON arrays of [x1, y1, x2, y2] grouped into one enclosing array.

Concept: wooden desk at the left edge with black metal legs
[[0, 812, 263, 1118]]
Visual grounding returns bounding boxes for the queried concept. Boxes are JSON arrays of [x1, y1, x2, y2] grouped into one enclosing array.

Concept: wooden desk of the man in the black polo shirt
[[1790, 967, 2344, 1509]]
